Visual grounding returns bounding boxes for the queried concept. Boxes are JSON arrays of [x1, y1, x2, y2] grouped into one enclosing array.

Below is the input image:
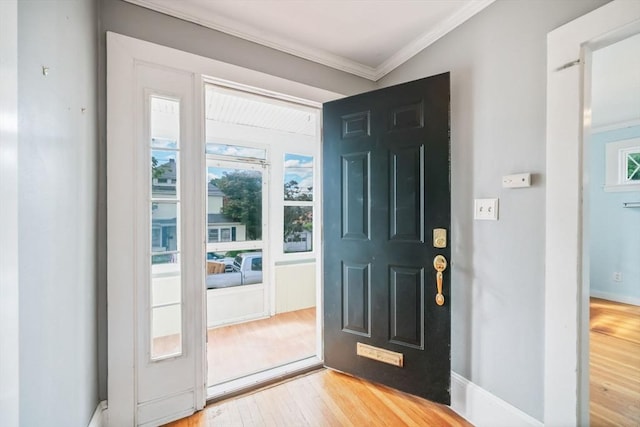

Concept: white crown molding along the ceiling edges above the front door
[[125, 0, 495, 81]]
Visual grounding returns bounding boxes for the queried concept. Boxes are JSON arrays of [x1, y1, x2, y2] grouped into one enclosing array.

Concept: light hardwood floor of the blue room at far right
[[589, 298, 640, 427]]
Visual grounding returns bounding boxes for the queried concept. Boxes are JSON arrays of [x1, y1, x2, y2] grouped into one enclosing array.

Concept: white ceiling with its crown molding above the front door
[[126, 0, 495, 81]]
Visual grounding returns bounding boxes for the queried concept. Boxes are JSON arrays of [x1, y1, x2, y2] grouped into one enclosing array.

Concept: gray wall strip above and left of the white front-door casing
[[95, 0, 376, 399]]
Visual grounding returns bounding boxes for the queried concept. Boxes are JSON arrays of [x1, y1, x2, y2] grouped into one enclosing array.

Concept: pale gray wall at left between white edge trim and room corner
[[18, 0, 98, 427]]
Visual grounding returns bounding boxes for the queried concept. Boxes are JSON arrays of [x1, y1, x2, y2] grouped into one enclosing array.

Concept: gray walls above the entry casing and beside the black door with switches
[[91, 0, 607, 419]]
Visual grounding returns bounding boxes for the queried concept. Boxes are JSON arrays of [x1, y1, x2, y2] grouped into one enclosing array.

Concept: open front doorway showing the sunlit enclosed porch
[[203, 80, 322, 399]]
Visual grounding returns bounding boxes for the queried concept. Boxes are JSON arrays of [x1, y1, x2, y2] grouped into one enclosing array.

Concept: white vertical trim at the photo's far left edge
[[0, 0, 20, 427]]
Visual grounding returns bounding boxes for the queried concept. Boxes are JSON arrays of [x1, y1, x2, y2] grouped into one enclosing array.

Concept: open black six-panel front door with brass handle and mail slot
[[323, 73, 451, 404]]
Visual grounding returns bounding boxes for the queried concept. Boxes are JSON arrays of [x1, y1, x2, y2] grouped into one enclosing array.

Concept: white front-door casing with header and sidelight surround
[[107, 32, 342, 426]]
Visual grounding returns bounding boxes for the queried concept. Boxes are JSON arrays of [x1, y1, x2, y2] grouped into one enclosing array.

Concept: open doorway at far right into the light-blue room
[[582, 34, 640, 425]]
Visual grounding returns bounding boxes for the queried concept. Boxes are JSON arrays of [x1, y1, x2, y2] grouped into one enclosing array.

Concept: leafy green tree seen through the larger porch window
[[211, 171, 262, 240]]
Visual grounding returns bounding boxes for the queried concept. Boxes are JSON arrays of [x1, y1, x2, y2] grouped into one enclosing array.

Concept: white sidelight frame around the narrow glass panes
[[107, 38, 205, 425]]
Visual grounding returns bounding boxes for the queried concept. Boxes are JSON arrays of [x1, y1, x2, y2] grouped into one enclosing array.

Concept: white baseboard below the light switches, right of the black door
[[451, 371, 543, 427]]
